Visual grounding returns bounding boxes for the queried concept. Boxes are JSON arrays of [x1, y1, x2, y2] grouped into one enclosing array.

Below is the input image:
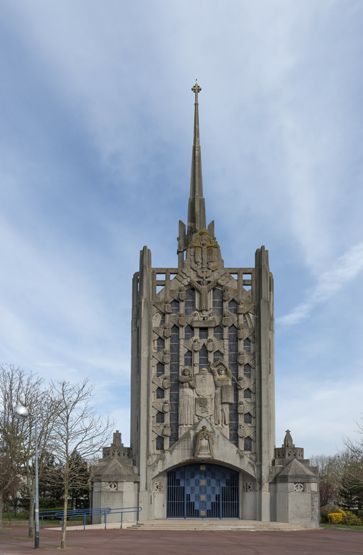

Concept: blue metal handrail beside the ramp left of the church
[[39, 507, 142, 530]]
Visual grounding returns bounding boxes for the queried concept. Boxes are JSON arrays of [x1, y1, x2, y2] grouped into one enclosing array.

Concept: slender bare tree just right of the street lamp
[[52, 380, 110, 549]]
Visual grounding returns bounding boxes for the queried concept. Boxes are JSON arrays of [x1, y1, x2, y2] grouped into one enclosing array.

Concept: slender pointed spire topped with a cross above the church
[[187, 81, 206, 237]]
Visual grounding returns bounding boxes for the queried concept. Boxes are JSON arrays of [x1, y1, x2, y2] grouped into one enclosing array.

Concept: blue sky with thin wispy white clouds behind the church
[[0, 0, 363, 456]]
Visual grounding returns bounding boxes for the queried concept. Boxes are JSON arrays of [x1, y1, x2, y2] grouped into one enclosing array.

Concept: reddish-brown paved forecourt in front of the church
[[0, 527, 363, 555]]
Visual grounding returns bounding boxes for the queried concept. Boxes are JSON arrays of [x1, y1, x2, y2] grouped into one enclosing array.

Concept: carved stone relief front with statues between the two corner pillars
[[152, 237, 255, 452]]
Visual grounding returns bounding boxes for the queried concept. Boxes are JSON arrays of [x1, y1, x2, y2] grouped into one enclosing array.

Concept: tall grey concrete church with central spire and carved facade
[[93, 83, 319, 527]]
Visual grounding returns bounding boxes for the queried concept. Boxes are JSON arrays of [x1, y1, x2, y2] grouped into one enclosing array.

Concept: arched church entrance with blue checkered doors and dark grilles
[[167, 464, 239, 518]]
